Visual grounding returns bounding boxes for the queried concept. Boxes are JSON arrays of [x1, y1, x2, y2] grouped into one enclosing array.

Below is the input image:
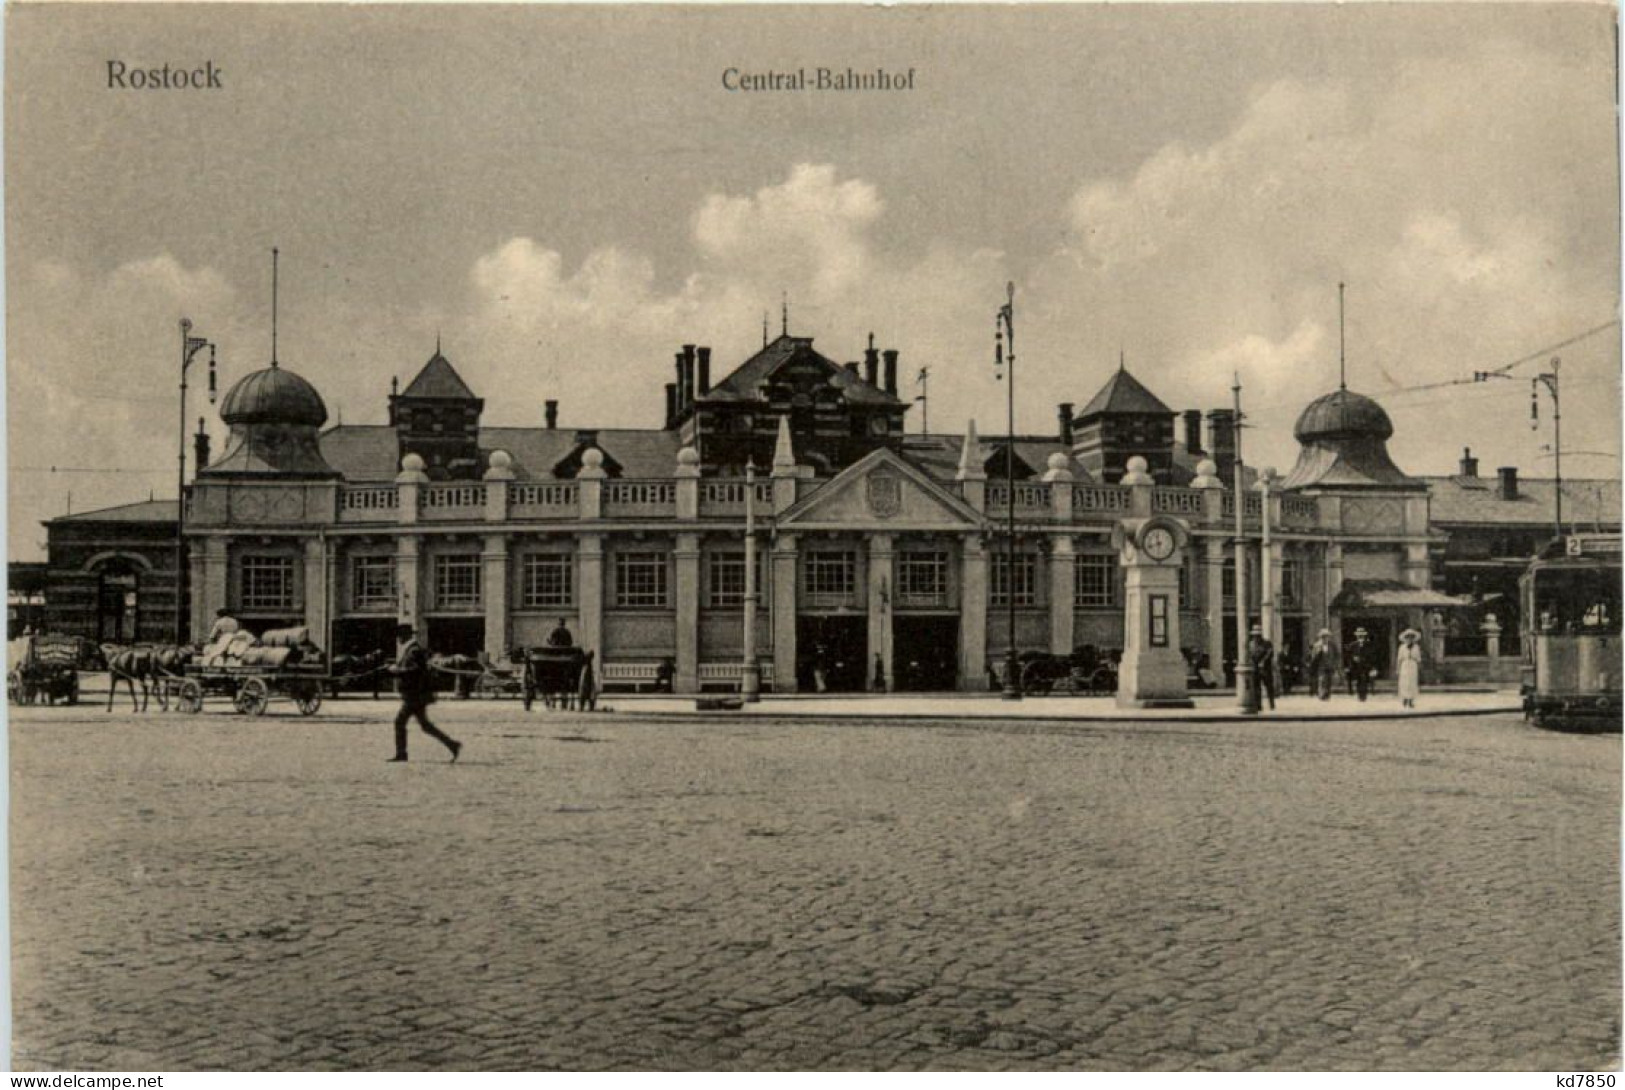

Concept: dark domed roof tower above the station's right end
[[1281, 388, 1427, 491]]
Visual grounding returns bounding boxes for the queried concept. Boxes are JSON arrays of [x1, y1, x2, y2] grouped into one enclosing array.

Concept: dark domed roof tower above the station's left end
[[202, 361, 340, 479]]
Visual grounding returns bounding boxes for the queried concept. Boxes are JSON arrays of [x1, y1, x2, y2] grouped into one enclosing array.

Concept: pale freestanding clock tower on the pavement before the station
[[1112, 515, 1194, 708]]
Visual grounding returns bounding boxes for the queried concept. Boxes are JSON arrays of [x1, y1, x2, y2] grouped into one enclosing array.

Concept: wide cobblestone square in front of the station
[[10, 702, 1620, 1071]]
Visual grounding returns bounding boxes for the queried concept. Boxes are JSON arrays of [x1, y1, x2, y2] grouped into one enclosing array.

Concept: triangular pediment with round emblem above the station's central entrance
[[778, 450, 982, 531]]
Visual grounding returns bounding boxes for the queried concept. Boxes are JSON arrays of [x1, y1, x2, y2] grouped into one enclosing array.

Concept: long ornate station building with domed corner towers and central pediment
[[168, 333, 1488, 692]]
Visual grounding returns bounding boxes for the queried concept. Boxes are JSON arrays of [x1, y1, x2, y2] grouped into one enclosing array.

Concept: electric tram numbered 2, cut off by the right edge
[[1518, 533, 1625, 731]]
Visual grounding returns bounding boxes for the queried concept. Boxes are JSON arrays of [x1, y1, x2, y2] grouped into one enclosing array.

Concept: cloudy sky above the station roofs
[[5, 3, 1620, 559]]
